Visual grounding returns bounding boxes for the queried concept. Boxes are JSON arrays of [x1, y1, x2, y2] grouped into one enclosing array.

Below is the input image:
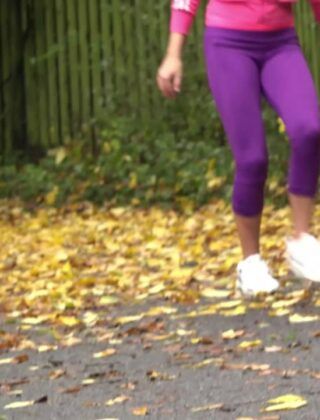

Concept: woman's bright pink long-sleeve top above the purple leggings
[[170, 0, 320, 35]]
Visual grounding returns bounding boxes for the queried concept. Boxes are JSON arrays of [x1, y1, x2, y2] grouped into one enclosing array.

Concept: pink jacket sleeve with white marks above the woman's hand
[[170, 0, 200, 35]]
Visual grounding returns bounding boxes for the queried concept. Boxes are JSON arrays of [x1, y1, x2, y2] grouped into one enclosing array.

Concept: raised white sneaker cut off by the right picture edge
[[286, 233, 320, 282]]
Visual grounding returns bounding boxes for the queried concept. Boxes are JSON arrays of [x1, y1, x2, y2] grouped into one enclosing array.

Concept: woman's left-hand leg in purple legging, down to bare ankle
[[205, 38, 268, 257]]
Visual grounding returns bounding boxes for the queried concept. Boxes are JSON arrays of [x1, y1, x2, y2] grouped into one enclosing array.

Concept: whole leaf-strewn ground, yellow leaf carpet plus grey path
[[0, 201, 320, 420]]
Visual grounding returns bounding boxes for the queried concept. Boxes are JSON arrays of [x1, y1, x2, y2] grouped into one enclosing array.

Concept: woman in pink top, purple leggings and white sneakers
[[157, 0, 320, 296]]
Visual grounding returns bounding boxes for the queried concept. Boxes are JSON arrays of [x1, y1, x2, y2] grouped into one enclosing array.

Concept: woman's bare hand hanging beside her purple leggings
[[157, 55, 183, 99]]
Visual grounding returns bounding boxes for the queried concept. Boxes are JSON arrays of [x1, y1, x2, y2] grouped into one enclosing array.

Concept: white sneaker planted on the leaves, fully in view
[[236, 254, 279, 296]]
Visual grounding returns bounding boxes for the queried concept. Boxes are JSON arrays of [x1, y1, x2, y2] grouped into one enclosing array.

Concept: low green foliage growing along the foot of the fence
[[0, 101, 288, 207]]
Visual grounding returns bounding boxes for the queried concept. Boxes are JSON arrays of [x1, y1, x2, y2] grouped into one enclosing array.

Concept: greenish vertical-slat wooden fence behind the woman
[[0, 0, 320, 156]]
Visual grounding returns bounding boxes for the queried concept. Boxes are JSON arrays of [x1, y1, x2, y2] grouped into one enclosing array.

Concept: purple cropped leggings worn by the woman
[[204, 27, 320, 216]]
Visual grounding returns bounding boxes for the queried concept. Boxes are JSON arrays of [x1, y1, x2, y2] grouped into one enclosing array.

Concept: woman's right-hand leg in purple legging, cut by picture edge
[[261, 45, 320, 238]]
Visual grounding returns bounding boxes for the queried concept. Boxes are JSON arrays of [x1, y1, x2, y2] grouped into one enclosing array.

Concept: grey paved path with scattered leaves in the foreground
[[0, 290, 320, 420]]
